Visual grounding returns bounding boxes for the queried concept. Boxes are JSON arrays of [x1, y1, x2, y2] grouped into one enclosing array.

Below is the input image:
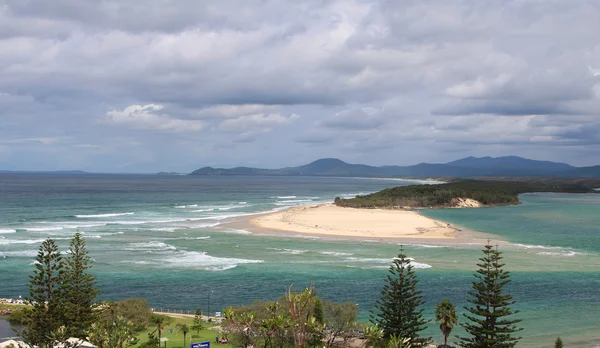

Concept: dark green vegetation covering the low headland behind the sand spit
[[335, 178, 600, 208]]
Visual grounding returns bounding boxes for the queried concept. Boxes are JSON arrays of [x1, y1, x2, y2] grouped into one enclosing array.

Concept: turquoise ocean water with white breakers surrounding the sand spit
[[0, 174, 600, 347]]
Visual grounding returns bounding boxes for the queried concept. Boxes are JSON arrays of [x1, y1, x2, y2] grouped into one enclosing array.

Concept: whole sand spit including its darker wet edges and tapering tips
[[224, 203, 496, 246]]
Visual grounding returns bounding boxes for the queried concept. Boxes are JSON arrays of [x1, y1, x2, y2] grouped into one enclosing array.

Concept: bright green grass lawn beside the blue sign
[[132, 318, 232, 348]]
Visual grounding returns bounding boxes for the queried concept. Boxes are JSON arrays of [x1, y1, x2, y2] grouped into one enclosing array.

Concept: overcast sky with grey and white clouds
[[0, 0, 600, 172]]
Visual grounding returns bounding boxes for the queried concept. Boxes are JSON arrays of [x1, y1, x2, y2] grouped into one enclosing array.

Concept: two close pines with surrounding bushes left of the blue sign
[[9, 233, 190, 348]]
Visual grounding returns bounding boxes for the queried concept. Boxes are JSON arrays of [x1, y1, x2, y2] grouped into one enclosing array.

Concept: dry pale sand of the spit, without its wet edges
[[249, 204, 457, 240]]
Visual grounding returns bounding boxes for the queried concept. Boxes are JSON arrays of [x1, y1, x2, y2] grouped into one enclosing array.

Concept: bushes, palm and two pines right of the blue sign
[[218, 243, 521, 348]]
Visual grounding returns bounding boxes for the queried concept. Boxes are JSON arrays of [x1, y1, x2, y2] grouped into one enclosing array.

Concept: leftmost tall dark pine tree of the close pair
[[22, 239, 64, 346]]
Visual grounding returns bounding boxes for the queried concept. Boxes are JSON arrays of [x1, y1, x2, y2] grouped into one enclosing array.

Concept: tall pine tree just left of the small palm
[[371, 247, 431, 347]]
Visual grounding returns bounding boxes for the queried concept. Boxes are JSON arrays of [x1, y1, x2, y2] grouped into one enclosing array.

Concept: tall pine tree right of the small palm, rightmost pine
[[459, 241, 522, 348]]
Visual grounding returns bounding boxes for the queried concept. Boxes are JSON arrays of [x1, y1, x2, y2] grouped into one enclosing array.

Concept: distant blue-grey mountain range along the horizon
[[191, 156, 600, 178]]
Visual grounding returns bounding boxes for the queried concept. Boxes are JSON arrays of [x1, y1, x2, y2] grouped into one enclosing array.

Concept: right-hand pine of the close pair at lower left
[[61, 233, 98, 338]]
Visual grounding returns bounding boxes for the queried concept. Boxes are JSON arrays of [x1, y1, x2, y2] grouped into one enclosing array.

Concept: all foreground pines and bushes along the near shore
[[11, 233, 562, 348]]
